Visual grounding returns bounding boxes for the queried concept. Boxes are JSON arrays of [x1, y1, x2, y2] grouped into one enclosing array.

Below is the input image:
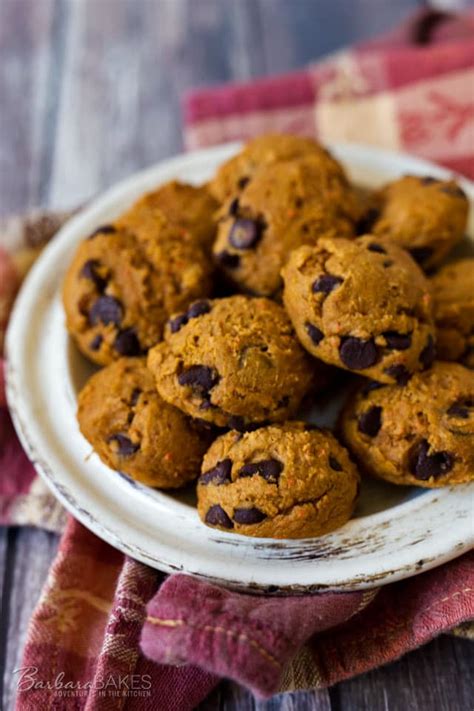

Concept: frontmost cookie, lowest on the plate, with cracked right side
[[197, 422, 359, 538]]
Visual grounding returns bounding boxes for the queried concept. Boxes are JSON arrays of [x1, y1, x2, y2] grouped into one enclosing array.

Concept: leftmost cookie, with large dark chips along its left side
[[63, 214, 212, 365]]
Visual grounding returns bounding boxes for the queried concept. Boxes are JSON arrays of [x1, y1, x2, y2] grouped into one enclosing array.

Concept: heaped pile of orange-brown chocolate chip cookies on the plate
[[63, 135, 474, 538]]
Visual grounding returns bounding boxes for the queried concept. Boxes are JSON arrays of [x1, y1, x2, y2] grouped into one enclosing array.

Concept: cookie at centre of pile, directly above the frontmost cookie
[[148, 296, 317, 429]]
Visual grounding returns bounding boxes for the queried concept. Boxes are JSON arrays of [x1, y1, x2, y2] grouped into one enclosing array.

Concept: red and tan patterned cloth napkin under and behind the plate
[[0, 6, 474, 711]]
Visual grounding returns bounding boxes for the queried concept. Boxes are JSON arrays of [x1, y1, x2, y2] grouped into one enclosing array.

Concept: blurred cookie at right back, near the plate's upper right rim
[[371, 175, 469, 270]]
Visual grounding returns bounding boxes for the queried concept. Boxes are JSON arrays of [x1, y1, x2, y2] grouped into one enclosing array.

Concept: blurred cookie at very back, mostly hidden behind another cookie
[[209, 133, 344, 202]]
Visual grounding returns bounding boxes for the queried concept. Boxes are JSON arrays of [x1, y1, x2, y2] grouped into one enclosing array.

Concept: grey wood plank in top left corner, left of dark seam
[[0, 0, 60, 214]]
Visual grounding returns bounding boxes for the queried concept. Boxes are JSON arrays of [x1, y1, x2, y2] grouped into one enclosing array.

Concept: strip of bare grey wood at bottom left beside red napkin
[[2, 528, 58, 709]]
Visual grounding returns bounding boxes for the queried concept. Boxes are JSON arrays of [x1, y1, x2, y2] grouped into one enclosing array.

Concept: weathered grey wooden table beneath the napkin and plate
[[0, 0, 474, 711]]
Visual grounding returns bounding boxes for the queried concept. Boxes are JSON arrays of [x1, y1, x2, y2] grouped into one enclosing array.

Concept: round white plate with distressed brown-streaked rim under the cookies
[[7, 144, 474, 592]]
